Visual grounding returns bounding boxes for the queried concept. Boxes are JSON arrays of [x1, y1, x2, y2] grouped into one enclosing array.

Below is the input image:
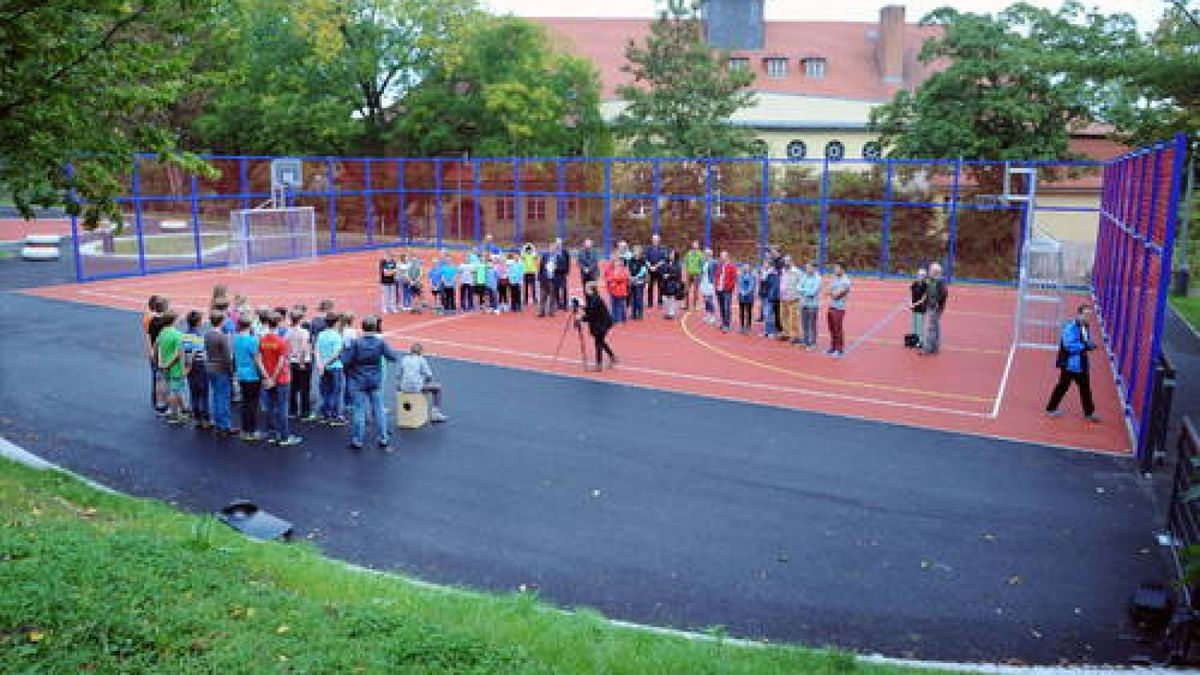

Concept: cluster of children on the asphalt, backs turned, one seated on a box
[[142, 286, 446, 447]]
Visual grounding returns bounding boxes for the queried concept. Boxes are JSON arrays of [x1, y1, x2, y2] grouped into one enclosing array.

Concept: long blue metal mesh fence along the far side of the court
[[63, 156, 1102, 282]]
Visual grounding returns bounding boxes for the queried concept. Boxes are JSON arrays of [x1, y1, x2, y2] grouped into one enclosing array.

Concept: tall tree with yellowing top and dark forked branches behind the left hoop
[[194, 0, 480, 155]]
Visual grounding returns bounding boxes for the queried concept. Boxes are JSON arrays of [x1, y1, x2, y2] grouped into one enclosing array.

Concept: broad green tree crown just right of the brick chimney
[[871, 2, 1136, 160]]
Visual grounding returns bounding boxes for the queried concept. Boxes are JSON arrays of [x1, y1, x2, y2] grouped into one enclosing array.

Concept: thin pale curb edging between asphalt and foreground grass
[[0, 437, 1180, 675]]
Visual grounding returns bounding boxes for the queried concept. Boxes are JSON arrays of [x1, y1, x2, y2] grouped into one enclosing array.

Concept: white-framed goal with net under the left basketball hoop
[[229, 207, 317, 269]]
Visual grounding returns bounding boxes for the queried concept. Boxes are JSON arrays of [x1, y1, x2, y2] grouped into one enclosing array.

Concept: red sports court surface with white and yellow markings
[[26, 252, 1132, 454]]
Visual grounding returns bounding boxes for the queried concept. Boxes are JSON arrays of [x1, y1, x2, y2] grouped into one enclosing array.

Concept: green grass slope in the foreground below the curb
[[0, 459, 945, 675]]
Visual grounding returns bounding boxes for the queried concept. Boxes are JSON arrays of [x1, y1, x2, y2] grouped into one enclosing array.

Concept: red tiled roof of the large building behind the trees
[[529, 17, 941, 101]]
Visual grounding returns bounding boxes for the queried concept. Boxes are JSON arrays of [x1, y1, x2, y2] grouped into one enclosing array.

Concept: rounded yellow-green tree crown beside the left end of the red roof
[[397, 17, 610, 156]]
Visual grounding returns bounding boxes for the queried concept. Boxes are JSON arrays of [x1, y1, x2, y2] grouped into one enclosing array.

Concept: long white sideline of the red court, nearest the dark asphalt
[[397, 329, 991, 419]]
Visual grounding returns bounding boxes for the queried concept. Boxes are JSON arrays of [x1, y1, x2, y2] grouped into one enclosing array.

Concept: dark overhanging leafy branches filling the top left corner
[[0, 0, 212, 223]]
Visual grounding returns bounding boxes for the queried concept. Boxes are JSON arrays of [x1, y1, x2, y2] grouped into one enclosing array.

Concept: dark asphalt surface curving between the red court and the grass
[[0, 251, 1165, 663]]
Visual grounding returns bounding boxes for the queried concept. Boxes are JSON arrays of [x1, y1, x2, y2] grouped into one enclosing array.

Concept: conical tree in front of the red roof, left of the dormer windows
[[616, 1, 754, 157]]
